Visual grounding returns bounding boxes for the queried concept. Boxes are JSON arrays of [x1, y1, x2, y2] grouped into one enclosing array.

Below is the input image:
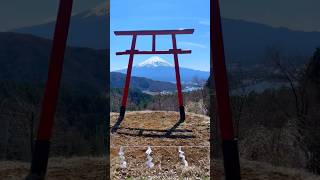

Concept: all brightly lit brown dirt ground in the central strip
[[110, 111, 210, 179]]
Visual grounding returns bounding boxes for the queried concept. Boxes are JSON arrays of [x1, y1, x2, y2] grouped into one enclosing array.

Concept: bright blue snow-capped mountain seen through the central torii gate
[[117, 56, 210, 84]]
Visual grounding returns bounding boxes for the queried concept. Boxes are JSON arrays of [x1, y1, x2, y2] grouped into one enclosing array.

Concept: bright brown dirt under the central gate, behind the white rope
[[110, 111, 210, 147]]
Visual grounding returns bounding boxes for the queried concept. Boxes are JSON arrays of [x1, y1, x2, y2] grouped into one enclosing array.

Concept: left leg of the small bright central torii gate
[[120, 35, 137, 118]]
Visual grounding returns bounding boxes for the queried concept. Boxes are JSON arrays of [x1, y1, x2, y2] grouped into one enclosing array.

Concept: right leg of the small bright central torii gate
[[172, 34, 185, 120]]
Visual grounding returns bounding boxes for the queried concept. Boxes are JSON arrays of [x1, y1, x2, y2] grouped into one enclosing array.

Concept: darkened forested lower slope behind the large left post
[[0, 81, 108, 161]]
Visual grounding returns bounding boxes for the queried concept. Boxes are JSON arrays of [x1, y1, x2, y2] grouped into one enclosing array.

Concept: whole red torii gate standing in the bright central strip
[[111, 29, 194, 133]]
